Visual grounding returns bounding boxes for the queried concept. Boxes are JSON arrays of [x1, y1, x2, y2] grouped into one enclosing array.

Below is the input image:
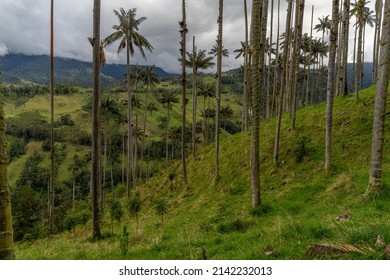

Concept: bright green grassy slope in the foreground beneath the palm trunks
[[12, 88, 390, 259]]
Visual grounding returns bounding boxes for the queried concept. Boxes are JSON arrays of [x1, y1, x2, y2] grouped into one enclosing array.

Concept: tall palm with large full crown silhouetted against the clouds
[[104, 8, 153, 197]]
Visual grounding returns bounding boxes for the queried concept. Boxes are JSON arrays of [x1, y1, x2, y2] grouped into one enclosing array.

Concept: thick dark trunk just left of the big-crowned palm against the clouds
[[91, 0, 101, 239]]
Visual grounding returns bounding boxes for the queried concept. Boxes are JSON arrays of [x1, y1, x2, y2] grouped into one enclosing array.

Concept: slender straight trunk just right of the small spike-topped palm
[[215, 0, 223, 183]]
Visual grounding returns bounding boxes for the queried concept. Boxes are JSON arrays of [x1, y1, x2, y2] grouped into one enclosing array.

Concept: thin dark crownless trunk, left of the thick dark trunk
[[49, 0, 55, 233]]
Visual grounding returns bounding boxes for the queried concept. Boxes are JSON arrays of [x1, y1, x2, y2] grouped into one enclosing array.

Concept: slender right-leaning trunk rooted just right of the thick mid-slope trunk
[[274, 0, 293, 163]]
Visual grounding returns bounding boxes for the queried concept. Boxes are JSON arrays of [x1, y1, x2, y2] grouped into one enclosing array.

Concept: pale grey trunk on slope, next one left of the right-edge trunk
[[325, 0, 339, 171]]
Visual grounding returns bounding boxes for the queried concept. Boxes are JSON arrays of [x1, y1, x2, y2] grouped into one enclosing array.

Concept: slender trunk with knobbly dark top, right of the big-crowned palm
[[179, 0, 188, 189]]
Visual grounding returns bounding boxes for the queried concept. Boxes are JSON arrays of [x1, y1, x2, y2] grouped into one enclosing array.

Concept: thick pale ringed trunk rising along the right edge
[[366, 0, 390, 194]]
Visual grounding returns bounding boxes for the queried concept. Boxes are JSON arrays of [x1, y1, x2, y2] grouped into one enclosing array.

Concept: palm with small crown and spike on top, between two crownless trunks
[[186, 42, 214, 157]]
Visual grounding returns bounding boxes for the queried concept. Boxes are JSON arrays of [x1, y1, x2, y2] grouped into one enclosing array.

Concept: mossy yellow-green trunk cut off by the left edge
[[0, 63, 15, 260]]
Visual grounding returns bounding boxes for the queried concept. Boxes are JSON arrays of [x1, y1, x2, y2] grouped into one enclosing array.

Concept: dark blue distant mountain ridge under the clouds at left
[[0, 54, 174, 87]]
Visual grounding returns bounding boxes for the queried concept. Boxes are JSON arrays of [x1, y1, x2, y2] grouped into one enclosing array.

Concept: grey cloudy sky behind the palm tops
[[0, 0, 375, 73]]
